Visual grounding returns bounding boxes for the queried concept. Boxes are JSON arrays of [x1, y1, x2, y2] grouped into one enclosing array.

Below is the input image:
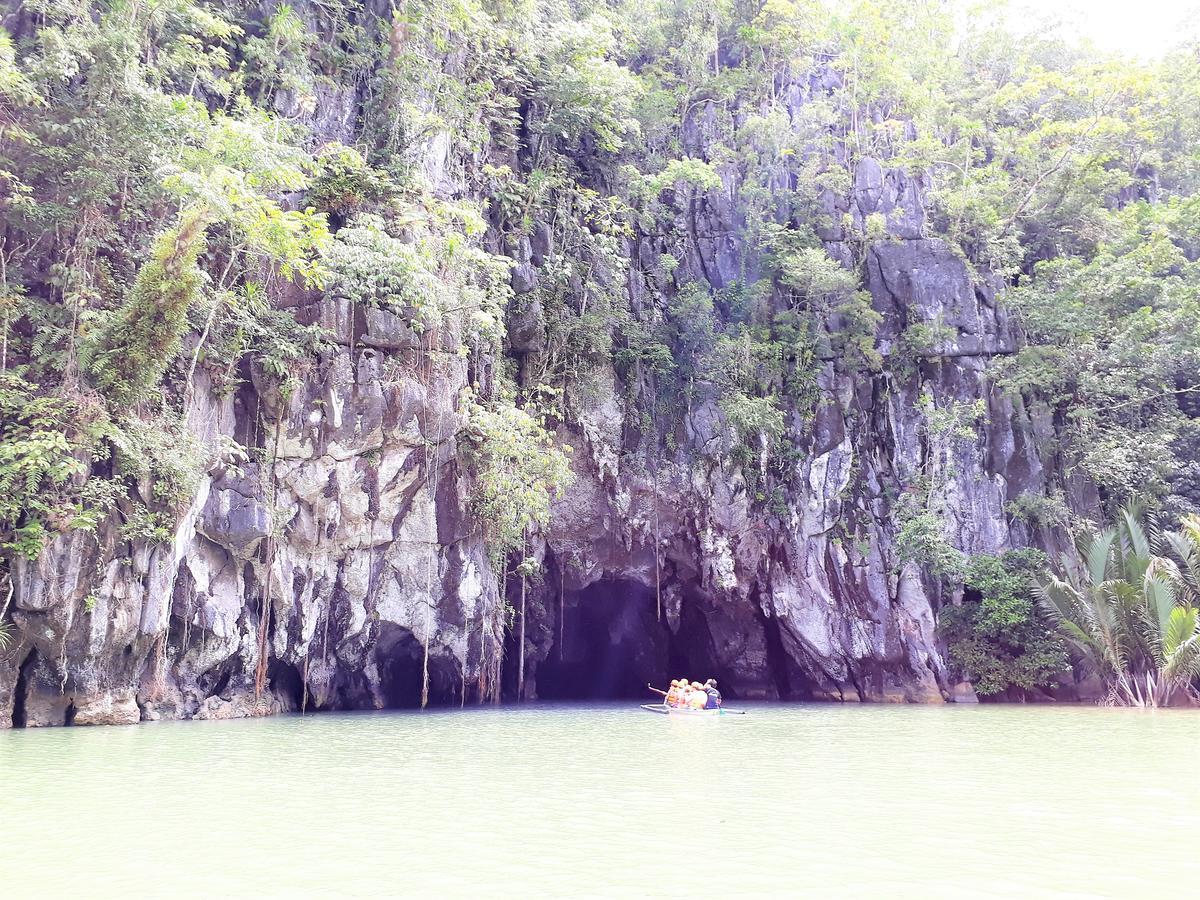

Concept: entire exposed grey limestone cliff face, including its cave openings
[[0, 15, 1091, 727]]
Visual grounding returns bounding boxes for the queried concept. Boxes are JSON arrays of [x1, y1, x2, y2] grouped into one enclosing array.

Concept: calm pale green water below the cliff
[[0, 703, 1200, 898]]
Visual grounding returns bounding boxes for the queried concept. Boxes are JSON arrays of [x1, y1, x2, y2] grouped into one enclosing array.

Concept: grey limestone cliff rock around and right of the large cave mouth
[[516, 153, 1092, 702]]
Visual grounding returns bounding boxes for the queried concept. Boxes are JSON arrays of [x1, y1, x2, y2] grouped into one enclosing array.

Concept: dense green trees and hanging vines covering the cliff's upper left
[[0, 0, 328, 564]]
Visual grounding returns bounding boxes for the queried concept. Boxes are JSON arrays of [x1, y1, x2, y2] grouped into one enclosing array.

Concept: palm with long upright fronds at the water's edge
[[1038, 505, 1200, 707]]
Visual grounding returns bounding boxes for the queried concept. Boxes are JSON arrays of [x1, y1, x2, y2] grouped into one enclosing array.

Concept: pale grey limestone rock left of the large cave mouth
[[0, 289, 498, 725]]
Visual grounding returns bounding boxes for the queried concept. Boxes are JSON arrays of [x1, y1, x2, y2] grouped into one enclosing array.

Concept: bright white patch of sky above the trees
[[1014, 0, 1200, 59]]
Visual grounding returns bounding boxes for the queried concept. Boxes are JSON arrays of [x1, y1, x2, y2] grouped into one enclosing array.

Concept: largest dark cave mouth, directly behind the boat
[[536, 578, 672, 702]]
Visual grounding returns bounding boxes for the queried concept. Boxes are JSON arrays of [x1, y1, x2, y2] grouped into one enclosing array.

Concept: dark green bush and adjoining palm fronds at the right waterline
[[938, 504, 1200, 707]]
